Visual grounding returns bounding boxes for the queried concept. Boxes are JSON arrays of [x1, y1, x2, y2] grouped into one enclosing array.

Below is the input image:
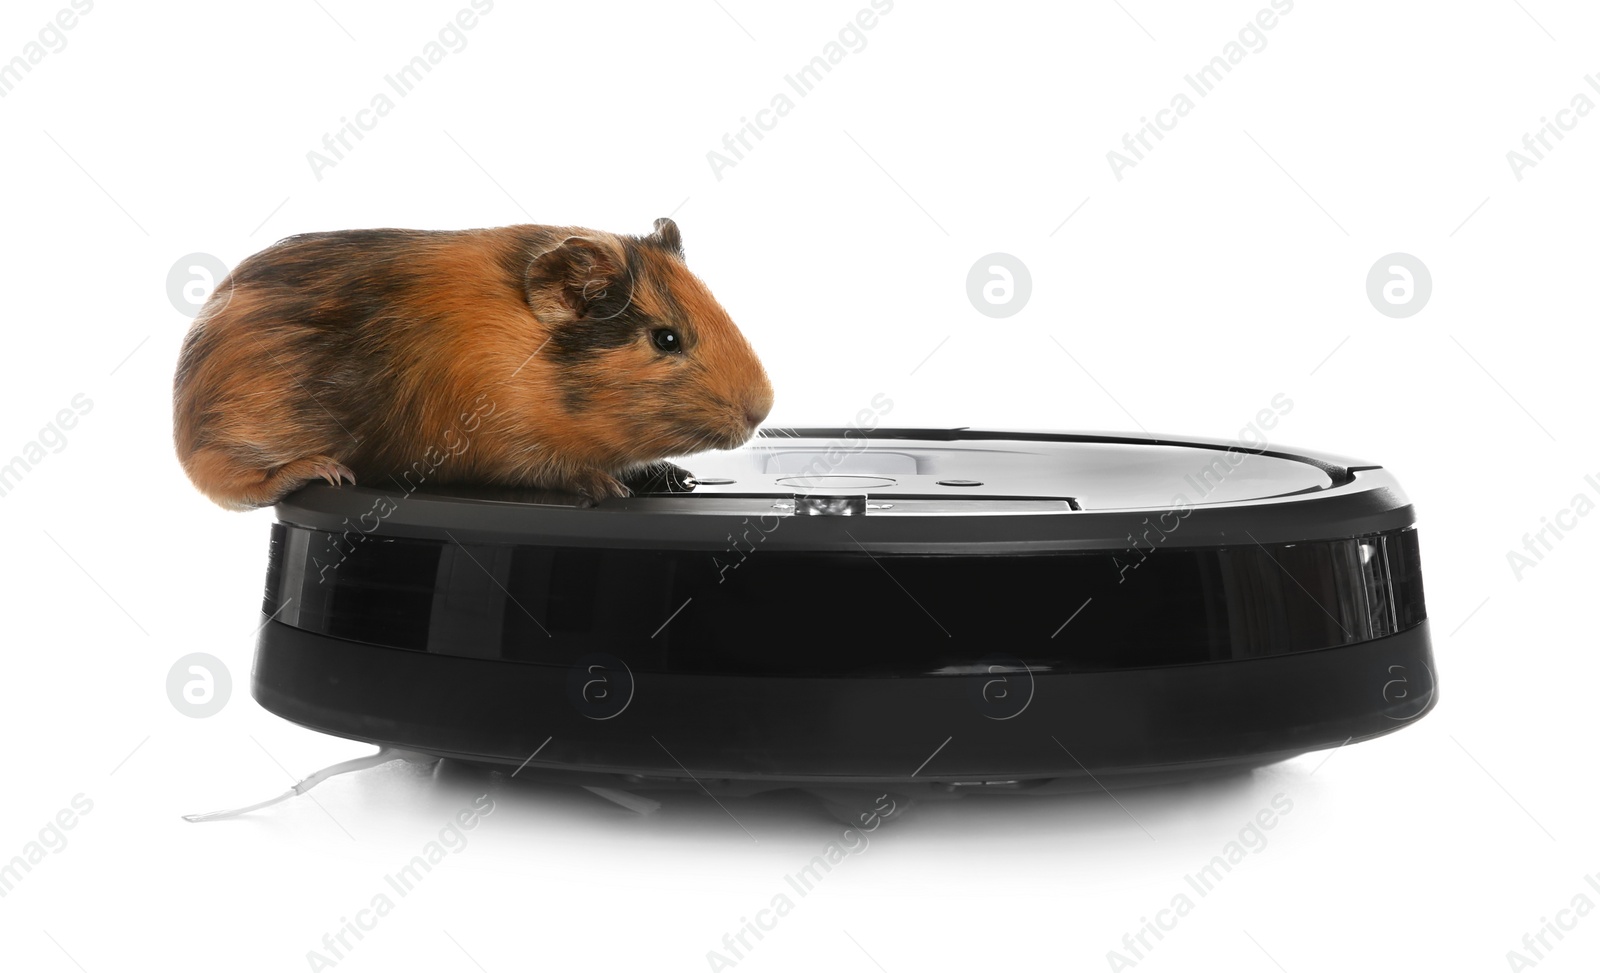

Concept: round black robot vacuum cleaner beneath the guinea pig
[[251, 429, 1435, 792]]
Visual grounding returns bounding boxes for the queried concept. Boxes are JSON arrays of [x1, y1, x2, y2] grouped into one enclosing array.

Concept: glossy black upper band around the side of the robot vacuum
[[262, 523, 1426, 675]]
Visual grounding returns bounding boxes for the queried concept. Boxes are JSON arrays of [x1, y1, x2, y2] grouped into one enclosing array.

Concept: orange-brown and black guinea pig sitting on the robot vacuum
[[173, 219, 773, 509]]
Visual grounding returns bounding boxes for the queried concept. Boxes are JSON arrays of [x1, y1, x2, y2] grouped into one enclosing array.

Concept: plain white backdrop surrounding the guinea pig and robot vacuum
[[0, 0, 1600, 973]]
